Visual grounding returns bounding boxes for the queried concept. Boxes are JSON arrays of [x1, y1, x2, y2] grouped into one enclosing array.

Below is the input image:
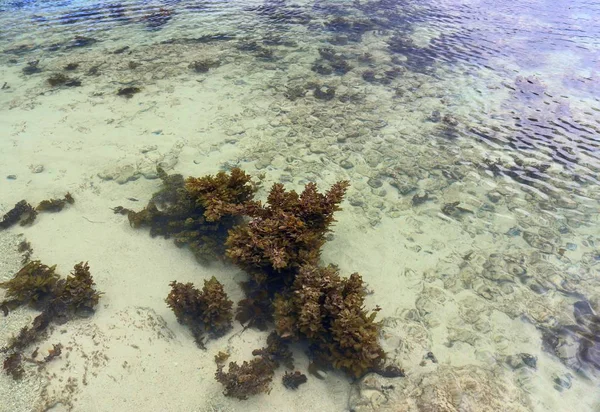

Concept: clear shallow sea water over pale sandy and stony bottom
[[0, 0, 600, 412]]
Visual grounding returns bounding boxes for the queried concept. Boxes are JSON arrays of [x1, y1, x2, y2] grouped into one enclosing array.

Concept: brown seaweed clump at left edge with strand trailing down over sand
[[0, 260, 102, 379]]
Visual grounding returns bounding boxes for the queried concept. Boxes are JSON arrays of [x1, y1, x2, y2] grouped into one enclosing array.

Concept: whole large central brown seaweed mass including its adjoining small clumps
[[120, 168, 386, 399]]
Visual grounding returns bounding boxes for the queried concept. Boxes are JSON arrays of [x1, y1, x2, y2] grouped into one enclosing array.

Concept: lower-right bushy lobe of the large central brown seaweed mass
[[274, 265, 385, 377]]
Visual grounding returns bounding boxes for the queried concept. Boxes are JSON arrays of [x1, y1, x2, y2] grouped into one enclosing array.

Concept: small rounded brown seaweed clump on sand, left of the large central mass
[[166, 276, 233, 348]]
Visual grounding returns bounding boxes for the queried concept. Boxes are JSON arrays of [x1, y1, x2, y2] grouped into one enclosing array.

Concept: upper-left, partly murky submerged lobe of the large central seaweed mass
[[118, 166, 255, 262]]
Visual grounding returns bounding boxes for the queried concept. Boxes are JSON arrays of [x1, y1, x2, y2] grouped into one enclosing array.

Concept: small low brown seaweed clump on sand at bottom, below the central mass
[[215, 356, 275, 400]]
